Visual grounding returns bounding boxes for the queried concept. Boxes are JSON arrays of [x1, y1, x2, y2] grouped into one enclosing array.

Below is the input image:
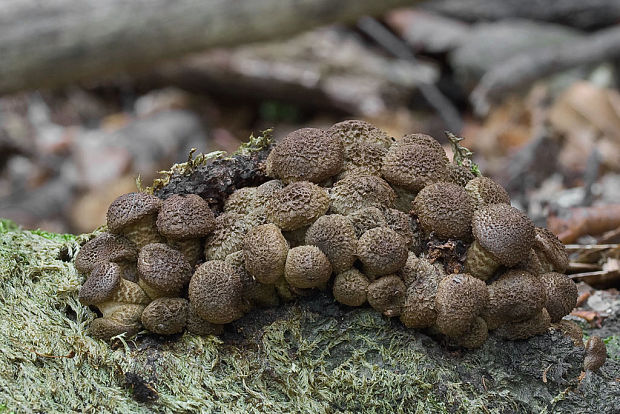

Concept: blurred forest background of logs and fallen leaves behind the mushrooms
[[0, 0, 620, 258]]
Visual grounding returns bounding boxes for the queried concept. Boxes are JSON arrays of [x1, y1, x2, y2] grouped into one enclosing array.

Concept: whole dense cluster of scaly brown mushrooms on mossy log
[[75, 121, 577, 348]]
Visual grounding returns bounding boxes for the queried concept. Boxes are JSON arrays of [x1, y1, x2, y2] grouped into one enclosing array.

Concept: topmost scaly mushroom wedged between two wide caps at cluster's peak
[[326, 120, 392, 178]]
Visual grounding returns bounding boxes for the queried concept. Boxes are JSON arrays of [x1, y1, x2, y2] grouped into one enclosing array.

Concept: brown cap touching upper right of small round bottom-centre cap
[[306, 214, 357, 273]]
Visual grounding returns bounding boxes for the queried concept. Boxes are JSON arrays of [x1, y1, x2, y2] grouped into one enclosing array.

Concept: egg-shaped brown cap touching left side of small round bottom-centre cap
[[243, 224, 288, 283]]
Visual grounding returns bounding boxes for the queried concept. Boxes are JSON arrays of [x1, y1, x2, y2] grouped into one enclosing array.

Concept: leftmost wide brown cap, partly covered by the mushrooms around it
[[75, 233, 138, 275]]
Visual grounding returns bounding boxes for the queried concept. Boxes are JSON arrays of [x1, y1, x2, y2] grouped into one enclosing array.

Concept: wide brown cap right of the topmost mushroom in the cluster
[[381, 143, 448, 191]]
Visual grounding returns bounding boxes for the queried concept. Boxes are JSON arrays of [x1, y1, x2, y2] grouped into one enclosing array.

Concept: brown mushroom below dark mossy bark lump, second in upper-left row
[[157, 194, 215, 266]]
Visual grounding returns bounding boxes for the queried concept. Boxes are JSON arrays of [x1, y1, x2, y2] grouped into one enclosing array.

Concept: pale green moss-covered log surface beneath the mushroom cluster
[[0, 220, 620, 413]]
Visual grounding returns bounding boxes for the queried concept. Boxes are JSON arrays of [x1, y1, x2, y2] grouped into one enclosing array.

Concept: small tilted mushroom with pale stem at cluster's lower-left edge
[[78, 262, 150, 308]]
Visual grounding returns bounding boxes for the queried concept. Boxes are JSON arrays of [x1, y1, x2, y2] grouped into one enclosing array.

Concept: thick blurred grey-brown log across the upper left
[[0, 0, 417, 93]]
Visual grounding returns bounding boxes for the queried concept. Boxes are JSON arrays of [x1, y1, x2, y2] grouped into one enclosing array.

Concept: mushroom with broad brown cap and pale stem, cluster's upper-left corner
[[107, 193, 164, 249]]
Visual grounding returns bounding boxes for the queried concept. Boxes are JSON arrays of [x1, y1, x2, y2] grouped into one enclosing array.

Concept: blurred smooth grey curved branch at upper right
[[470, 27, 620, 115]]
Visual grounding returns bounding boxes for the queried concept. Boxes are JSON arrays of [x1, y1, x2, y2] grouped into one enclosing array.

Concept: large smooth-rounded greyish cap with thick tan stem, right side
[[465, 204, 534, 280]]
